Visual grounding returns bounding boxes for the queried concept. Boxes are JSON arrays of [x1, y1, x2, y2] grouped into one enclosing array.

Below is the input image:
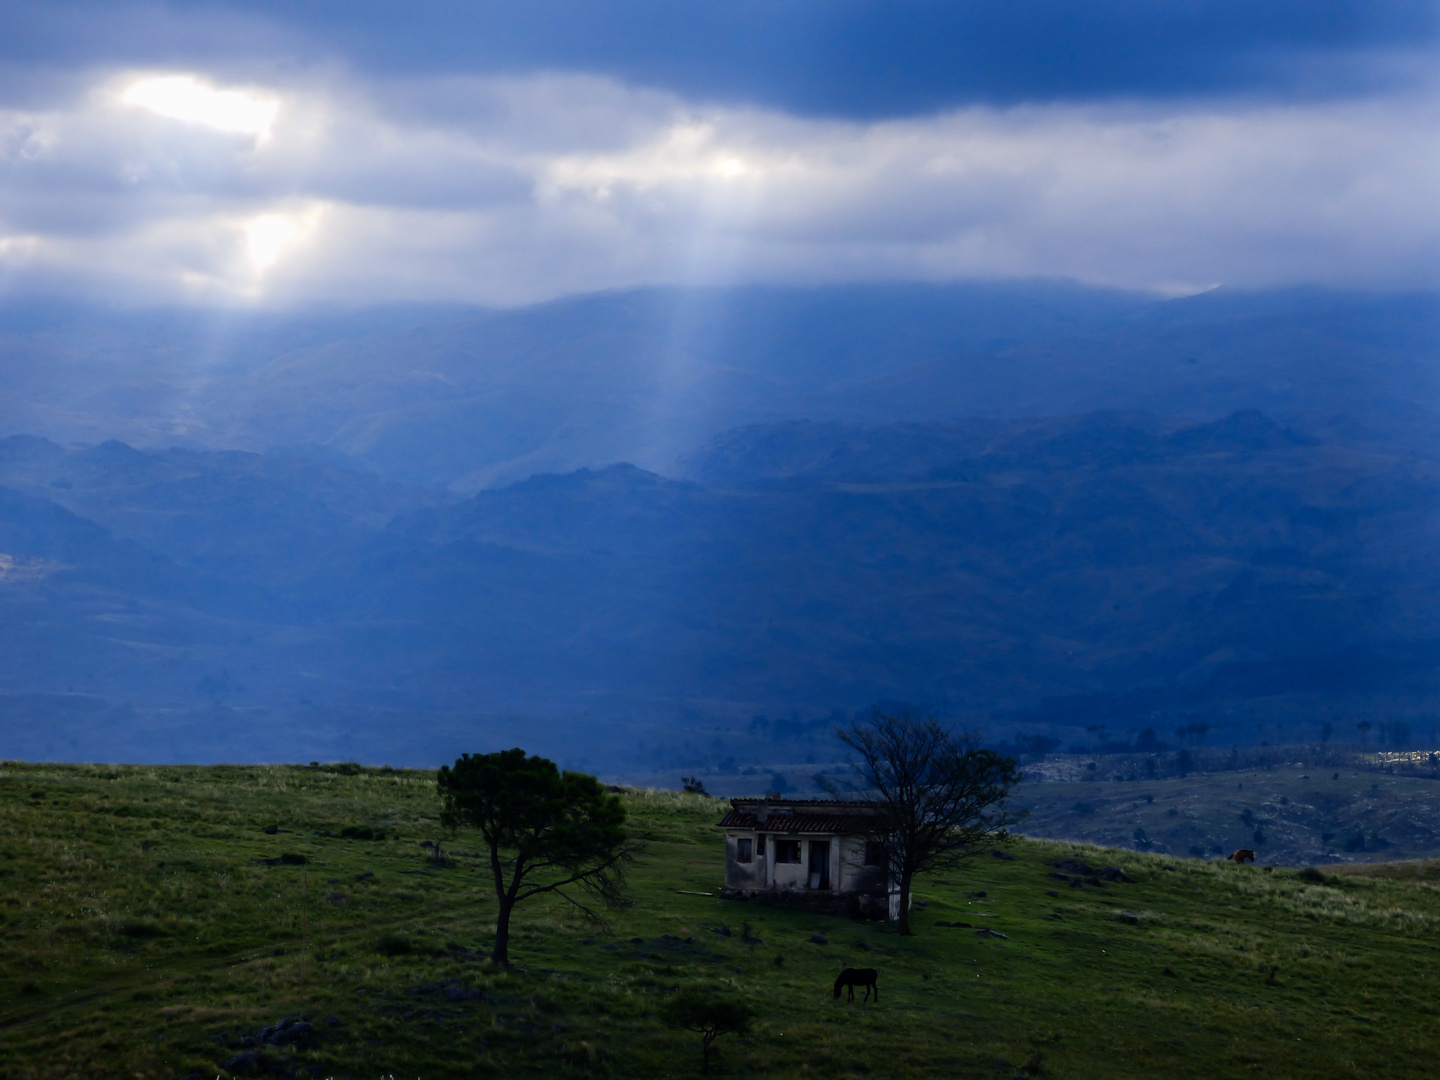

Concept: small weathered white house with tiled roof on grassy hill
[[720, 792, 900, 919]]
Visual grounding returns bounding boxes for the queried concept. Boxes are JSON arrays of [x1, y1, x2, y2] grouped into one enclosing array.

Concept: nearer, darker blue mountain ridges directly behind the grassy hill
[[0, 413, 1440, 763]]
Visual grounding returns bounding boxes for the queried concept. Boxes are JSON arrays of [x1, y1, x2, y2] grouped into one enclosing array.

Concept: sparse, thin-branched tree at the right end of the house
[[821, 710, 1020, 935]]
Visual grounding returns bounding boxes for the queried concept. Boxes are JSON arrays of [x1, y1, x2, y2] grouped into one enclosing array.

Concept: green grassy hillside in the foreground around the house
[[0, 763, 1440, 1080]]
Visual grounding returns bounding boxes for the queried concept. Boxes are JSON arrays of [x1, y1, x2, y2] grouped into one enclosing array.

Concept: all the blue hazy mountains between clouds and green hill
[[0, 284, 1440, 773]]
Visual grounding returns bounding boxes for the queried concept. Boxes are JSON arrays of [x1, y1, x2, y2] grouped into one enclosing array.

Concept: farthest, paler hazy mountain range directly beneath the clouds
[[0, 282, 1440, 494]]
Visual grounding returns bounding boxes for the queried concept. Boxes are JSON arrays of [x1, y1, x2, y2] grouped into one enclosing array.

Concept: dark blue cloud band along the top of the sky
[[0, 0, 1440, 118]]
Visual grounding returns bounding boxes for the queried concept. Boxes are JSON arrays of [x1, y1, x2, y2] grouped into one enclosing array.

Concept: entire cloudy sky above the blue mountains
[[0, 0, 1440, 308]]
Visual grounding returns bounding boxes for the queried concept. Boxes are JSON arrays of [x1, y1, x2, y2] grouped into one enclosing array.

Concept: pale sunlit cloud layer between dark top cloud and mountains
[[0, 75, 1440, 304]]
